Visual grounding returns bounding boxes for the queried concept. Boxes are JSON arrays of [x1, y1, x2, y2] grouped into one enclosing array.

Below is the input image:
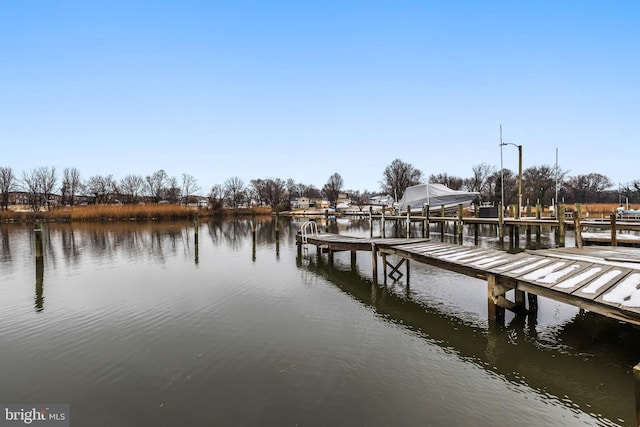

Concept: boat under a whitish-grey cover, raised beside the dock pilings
[[398, 183, 480, 211]]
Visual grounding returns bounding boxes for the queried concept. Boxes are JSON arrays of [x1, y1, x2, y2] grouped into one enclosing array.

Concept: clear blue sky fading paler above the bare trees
[[0, 0, 640, 195]]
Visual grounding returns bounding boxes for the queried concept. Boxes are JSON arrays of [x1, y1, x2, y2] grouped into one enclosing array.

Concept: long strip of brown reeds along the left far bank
[[0, 204, 271, 222]]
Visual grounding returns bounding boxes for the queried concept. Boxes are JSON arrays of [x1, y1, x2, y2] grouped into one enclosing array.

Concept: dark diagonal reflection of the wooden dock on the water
[[297, 255, 640, 423]]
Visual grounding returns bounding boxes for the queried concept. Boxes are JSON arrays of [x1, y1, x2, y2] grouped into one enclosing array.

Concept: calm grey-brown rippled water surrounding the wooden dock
[[0, 219, 640, 426]]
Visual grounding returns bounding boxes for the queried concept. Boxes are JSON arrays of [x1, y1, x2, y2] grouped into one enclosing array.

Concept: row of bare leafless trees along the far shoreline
[[0, 159, 640, 210]]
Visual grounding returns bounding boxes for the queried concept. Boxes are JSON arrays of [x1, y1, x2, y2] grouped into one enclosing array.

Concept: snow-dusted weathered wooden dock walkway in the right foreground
[[298, 234, 640, 325]]
